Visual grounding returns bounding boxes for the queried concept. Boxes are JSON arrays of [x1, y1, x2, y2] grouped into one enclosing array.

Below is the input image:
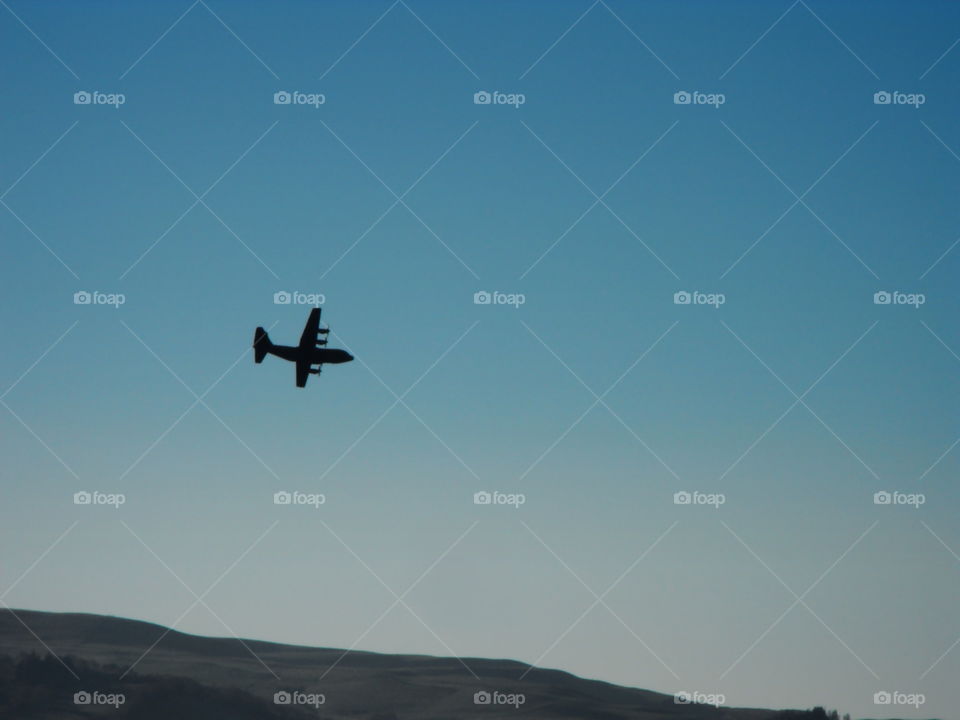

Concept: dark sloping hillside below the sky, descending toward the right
[[0, 610, 848, 720]]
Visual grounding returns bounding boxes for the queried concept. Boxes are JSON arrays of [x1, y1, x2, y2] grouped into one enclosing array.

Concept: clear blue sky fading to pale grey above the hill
[[0, 0, 960, 717]]
